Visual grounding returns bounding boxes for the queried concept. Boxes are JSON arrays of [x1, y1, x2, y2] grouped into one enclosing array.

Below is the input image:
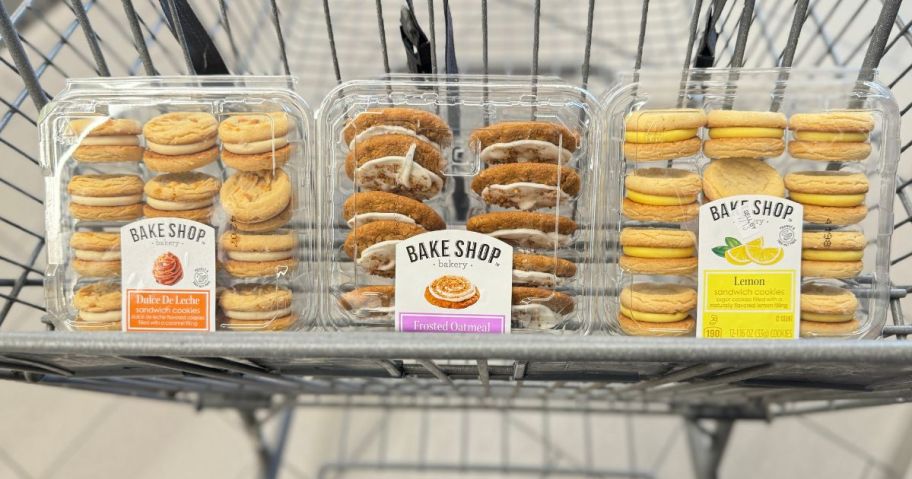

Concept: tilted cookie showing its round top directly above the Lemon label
[[703, 158, 785, 201]]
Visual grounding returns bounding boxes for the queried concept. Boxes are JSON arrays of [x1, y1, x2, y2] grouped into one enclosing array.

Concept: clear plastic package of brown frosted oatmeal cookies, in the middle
[[317, 76, 612, 334]]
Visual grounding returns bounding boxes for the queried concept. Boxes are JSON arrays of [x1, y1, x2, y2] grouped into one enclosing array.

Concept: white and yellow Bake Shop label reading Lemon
[[697, 195, 804, 339]]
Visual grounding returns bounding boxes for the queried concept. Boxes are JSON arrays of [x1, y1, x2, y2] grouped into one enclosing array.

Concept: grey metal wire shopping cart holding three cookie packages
[[0, 0, 912, 477]]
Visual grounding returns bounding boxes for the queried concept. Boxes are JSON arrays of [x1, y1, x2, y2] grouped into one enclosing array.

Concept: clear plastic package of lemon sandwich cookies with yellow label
[[604, 69, 899, 339]]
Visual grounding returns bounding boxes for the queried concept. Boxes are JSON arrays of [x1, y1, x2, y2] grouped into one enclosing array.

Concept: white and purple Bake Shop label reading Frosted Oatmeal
[[395, 230, 513, 334]]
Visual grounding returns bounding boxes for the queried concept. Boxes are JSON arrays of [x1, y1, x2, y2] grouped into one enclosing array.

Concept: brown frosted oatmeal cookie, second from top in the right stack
[[472, 163, 580, 210]]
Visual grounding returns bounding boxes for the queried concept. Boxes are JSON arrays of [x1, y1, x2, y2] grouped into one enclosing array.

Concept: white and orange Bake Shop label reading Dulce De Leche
[[120, 218, 216, 331]]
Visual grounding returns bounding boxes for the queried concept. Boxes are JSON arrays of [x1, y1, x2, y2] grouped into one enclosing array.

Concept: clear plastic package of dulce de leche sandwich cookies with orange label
[[39, 77, 316, 332]]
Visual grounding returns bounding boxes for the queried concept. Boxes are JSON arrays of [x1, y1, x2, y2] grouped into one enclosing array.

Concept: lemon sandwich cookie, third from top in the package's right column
[[801, 231, 867, 278]]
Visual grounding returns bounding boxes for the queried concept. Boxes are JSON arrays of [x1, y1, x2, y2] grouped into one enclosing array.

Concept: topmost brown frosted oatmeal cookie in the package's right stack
[[469, 121, 580, 165]]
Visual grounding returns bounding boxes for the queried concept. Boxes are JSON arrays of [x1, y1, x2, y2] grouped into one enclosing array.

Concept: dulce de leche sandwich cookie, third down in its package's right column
[[219, 230, 297, 278]]
